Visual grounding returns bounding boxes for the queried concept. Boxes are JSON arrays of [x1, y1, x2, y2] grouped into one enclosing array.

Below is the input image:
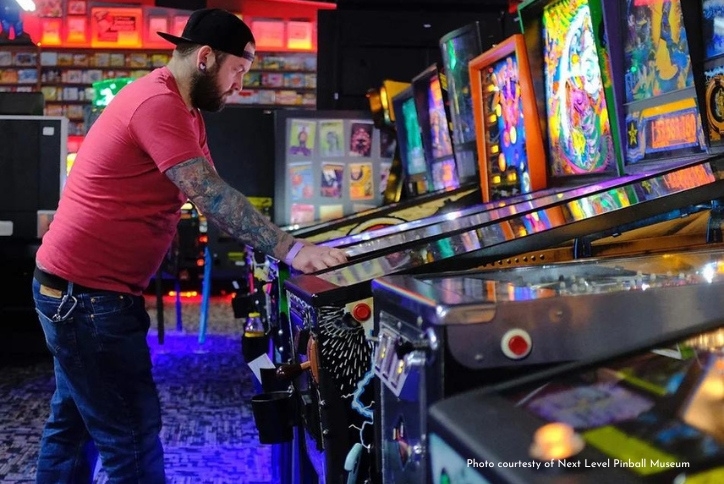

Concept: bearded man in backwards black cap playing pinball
[[33, 9, 345, 484]]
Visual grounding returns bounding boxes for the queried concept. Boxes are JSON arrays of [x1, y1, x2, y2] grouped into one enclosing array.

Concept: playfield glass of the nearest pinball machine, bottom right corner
[[505, 329, 724, 474]]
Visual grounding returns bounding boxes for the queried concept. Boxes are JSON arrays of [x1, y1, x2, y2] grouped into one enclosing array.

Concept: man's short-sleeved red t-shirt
[[37, 67, 213, 294]]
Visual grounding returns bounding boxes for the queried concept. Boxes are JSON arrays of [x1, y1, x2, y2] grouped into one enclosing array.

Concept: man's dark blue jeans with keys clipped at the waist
[[33, 280, 166, 484]]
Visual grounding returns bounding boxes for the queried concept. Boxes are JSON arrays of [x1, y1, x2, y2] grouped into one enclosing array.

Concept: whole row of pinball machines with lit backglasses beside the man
[[235, 0, 724, 484]]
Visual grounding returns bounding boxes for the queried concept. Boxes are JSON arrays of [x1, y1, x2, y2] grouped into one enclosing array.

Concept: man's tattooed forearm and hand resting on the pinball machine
[[166, 158, 346, 272]]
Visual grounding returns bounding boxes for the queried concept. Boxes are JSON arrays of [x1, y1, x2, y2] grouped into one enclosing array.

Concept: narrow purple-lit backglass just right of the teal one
[[412, 65, 460, 191]]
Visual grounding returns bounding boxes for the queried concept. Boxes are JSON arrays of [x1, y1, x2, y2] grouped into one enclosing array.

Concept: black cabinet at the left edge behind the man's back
[[0, 114, 68, 364]]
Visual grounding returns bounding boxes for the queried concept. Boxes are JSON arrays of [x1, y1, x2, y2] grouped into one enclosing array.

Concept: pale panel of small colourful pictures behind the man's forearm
[[274, 110, 394, 225]]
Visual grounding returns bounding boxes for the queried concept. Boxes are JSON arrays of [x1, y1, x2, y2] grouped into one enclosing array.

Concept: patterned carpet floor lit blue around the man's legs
[[0, 298, 278, 484]]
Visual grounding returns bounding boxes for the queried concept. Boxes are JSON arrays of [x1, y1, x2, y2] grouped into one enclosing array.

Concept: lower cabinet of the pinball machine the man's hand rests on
[[285, 158, 722, 482]]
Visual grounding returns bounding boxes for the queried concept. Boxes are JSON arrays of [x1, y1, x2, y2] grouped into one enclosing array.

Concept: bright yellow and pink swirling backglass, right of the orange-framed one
[[518, 0, 620, 179]]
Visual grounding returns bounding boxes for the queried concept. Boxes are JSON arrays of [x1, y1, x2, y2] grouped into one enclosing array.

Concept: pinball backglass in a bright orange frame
[[469, 34, 546, 202]]
